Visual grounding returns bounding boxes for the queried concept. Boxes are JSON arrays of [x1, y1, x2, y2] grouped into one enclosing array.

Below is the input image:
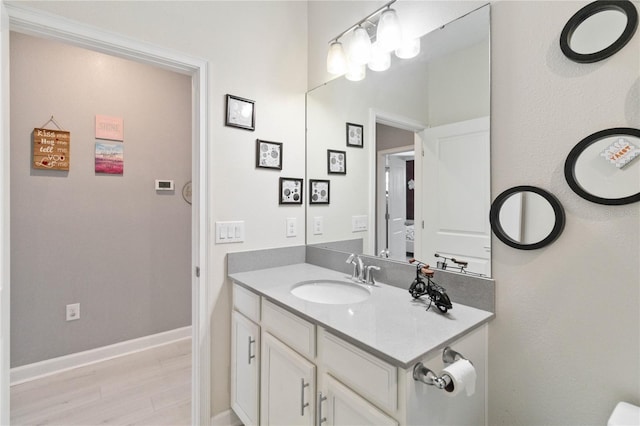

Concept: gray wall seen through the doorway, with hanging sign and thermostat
[[11, 33, 191, 367]]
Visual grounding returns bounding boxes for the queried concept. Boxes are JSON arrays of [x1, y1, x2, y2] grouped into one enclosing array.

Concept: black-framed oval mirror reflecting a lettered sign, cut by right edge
[[564, 127, 640, 205]]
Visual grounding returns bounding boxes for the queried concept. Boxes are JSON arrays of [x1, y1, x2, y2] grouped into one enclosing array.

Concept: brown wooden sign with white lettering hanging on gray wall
[[32, 127, 71, 170]]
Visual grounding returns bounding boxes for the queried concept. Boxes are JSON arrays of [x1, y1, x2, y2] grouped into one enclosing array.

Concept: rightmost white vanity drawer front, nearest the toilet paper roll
[[320, 332, 398, 412]]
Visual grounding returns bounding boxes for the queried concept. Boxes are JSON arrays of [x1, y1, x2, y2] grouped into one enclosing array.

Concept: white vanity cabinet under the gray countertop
[[232, 284, 487, 426]]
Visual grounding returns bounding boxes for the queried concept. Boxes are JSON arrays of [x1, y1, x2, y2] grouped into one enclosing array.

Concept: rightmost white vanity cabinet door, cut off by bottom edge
[[318, 374, 398, 426]]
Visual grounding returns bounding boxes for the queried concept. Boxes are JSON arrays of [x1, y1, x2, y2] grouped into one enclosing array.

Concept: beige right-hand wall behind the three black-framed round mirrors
[[309, 0, 640, 426]]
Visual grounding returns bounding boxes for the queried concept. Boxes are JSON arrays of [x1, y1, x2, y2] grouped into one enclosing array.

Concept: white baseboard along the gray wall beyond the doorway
[[10, 326, 191, 386]]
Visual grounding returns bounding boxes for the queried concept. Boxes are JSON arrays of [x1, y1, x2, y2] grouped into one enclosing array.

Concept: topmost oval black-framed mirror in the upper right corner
[[560, 0, 638, 63]]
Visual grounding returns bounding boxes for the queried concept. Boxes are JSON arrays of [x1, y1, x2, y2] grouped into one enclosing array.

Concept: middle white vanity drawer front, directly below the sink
[[262, 299, 316, 359]]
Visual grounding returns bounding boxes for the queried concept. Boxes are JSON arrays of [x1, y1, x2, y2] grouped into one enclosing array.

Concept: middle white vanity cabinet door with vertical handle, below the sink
[[260, 333, 316, 426]]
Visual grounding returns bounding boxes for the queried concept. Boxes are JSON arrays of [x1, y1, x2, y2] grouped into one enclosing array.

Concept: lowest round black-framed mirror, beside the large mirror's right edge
[[489, 185, 565, 250]]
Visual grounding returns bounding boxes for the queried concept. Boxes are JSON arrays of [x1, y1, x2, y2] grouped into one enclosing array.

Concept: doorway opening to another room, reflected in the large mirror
[[376, 123, 414, 261]]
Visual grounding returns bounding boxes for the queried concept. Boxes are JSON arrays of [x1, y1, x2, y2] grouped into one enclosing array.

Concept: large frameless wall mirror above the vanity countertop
[[306, 5, 491, 276]]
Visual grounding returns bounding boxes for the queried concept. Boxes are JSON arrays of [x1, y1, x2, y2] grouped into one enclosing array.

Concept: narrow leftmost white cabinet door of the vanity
[[231, 311, 260, 426]]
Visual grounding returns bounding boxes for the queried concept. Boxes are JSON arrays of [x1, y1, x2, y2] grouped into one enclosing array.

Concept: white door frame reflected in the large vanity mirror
[[363, 108, 429, 256]]
